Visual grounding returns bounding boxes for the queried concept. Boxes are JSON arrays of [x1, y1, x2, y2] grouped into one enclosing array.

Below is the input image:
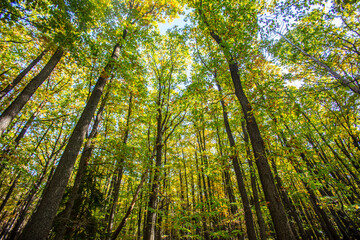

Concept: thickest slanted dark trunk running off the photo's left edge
[[0, 47, 64, 137]]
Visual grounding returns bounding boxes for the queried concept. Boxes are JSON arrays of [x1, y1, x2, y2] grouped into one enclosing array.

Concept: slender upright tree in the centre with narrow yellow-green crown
[[144, 33, 186, 240]]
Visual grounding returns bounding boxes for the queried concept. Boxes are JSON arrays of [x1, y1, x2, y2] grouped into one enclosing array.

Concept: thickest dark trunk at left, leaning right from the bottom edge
[[19, 40, 122, 240]]
